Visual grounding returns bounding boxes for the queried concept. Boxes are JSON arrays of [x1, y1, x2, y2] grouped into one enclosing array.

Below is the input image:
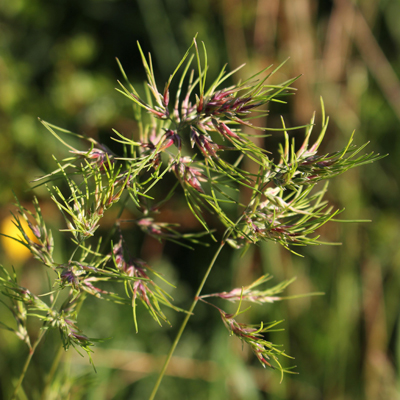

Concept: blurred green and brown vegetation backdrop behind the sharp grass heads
[[0, 0, 400, 400]]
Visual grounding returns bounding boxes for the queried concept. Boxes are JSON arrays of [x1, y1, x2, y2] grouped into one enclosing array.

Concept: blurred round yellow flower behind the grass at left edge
[[0, 215, 37, 263]]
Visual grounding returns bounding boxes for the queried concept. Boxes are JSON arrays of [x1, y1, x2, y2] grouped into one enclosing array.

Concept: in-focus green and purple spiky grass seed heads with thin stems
[[0, 38, 381, 400]]
